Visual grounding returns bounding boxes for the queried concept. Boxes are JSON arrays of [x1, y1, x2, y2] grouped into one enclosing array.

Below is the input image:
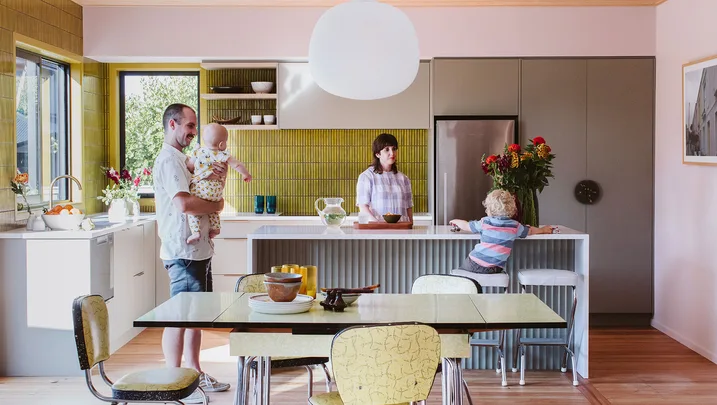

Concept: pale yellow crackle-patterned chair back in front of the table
[[331, 323, 441, 405]]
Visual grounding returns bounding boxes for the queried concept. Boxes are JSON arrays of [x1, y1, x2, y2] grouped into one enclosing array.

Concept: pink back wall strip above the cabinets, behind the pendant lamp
[[83, 7, 655, 62]]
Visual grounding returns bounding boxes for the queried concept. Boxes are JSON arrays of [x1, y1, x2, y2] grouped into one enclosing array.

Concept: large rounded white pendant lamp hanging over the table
[[309, 0, 420, 100]]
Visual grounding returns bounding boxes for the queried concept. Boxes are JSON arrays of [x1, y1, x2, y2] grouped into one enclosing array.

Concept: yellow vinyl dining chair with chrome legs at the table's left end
[[72, 295, 209, 405]]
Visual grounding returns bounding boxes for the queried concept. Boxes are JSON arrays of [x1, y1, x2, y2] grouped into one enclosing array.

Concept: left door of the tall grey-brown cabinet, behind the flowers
[[520, 59, 587, 232]]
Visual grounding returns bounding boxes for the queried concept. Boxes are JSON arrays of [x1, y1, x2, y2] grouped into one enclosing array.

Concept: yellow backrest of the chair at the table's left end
[[72, 295, 110, 370]]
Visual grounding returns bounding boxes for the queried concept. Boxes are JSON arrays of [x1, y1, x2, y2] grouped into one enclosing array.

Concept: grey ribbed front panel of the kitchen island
[[253, 240, 580, 370]]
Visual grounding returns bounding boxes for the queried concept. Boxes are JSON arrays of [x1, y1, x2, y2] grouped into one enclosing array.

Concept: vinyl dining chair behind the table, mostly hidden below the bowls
[[234, 274, 331, 404]]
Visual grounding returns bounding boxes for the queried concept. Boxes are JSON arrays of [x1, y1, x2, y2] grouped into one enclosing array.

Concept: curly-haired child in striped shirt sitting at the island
[[450, 190, 553, 274]]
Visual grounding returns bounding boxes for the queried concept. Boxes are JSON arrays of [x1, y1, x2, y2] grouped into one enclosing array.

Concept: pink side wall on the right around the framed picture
[[653, 0, 717, 362]]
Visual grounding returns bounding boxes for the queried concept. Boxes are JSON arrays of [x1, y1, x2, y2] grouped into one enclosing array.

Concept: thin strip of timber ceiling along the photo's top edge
[[73, 0, 667, 7]]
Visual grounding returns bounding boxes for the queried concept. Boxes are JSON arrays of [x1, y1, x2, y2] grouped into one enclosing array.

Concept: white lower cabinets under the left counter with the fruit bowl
[[0, 220, 156, 376]]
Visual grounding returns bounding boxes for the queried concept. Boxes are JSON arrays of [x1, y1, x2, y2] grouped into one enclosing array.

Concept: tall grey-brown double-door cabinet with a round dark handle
[[520, 58, 655, 314]]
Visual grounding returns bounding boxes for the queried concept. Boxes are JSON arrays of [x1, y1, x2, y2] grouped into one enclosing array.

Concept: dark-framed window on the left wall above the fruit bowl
[[15, 49, 70, 205]]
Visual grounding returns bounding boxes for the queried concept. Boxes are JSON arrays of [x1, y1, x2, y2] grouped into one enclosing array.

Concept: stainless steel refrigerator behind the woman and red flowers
[[434, 116, 518, 225]]
